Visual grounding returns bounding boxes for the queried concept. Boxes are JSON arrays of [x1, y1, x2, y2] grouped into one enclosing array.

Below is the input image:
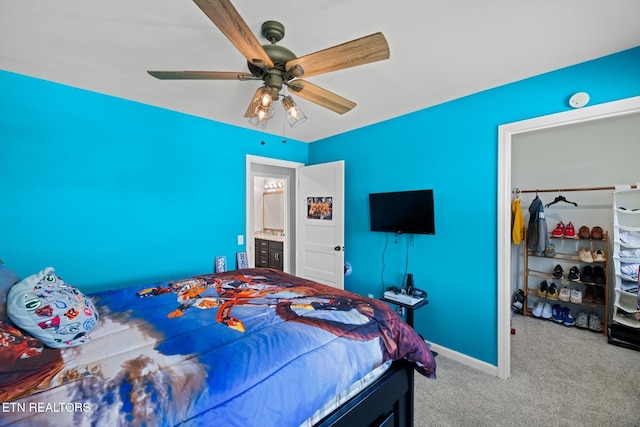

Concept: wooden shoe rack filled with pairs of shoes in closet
[[522, 227, 609, 334]]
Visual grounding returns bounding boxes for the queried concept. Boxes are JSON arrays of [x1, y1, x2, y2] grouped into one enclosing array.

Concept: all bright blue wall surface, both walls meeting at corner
[[0, 48, 640, 365]]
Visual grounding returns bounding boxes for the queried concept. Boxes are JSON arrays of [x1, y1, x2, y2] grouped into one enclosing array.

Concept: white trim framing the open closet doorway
[[497, 96, 640, 379]]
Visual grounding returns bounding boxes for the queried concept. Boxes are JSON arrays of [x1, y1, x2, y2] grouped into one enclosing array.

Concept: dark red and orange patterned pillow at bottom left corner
[[0, 322, 64, 402]]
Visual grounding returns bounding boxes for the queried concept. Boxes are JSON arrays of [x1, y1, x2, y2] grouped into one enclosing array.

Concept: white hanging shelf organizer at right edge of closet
[[612, 189, 640, 339]]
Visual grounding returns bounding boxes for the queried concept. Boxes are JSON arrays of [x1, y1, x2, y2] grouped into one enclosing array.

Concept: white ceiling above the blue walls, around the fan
[[0, 0, 640, 142]]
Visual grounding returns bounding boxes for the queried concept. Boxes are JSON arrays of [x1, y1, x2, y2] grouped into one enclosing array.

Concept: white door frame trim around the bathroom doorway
[[245, 154, 304, 271]]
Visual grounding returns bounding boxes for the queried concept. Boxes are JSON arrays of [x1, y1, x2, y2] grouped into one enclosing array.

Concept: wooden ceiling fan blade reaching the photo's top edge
[[193, 0, 273, 68]]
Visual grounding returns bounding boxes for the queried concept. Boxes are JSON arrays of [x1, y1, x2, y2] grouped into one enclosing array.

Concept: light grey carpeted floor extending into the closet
[[415, 316, 640, 427]]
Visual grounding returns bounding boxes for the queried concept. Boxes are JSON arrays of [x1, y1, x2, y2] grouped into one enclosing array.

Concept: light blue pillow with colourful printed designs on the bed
[[7, 267, 98, 348]]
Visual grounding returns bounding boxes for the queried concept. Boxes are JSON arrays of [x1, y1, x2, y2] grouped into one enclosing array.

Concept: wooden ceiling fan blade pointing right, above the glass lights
[[286, 33, 390, 77]]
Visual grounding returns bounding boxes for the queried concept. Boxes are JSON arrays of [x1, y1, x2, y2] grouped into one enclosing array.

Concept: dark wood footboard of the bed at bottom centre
[[316, 360, 414, 427]]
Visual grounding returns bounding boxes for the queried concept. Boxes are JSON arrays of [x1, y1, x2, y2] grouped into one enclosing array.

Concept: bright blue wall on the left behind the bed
[[0, 72, 308, 292]]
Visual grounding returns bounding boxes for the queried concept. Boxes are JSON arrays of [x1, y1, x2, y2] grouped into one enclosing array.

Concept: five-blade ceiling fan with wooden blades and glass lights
[[147, 0, 389, 128]]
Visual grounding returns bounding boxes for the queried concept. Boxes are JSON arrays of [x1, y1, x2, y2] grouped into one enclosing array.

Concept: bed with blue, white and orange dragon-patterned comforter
[[0, 268, 436, 427]]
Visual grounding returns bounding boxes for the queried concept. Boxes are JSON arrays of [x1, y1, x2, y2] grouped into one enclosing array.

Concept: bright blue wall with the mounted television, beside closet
[[309, 48, 640, 365]]
